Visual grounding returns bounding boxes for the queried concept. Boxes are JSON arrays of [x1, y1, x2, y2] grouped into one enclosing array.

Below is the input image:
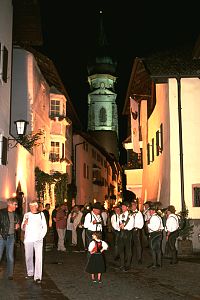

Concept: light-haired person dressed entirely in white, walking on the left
[[21, 200, 47, 283]]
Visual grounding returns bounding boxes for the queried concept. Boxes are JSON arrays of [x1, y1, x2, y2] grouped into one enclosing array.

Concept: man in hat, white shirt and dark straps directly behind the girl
[[84, 202, 103, 246]]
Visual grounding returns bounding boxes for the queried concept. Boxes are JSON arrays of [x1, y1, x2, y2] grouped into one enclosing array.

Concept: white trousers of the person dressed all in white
[[24, 239, 43, 280]]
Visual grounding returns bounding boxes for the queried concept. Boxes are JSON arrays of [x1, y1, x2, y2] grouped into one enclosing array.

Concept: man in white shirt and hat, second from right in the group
[[148, 203, 164, 268]]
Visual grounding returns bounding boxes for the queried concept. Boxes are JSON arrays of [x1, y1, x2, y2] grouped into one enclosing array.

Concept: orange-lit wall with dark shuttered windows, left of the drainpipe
[[142, 84, 170, 206]]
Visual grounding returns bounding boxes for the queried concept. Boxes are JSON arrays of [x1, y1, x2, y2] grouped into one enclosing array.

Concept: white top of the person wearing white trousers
[[21, 212, 47, 243]]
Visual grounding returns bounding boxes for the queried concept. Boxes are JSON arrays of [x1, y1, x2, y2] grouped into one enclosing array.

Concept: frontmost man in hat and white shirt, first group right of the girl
[[119, 201, 133, 271]]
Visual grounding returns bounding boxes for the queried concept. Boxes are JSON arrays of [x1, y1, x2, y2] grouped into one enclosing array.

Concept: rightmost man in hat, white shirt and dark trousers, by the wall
[[165, 205, 179, 264]]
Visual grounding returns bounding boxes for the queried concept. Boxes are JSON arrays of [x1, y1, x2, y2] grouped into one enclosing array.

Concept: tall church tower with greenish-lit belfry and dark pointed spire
[[88, 11, 119, 159]]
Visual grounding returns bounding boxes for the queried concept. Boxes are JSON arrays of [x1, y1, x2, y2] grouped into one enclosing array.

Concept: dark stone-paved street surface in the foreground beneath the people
[[0, 237, 200, 300]]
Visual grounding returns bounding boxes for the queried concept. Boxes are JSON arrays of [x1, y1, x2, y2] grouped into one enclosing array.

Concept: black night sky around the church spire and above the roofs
[[36, 0, 199, 157]]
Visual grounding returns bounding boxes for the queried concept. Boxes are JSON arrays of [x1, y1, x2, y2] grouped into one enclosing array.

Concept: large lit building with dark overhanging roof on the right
[[123, 47, 200, 250]]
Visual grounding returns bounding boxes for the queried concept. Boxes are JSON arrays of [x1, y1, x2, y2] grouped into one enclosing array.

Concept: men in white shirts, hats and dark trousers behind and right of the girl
[[84, 201, 179, 271]]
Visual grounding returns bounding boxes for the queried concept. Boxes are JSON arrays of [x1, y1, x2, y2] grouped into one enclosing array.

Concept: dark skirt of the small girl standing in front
[[85, 253, 106, 274]]
